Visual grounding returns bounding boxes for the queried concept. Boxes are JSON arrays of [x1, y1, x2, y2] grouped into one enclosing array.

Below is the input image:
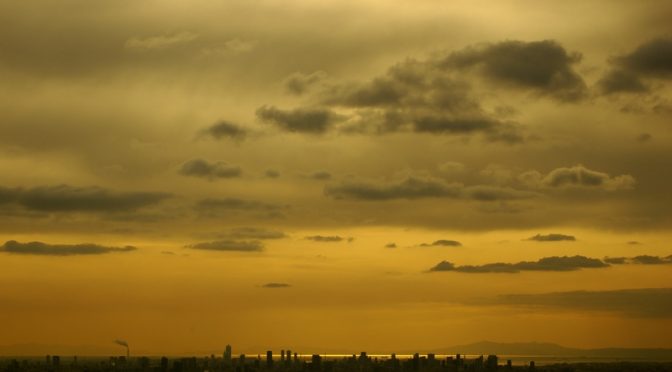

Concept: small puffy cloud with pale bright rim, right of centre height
[[519, 165, 636, 191]]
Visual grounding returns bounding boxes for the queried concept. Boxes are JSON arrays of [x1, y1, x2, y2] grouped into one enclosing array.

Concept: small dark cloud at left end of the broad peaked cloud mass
[[256, 106, 344, 134]]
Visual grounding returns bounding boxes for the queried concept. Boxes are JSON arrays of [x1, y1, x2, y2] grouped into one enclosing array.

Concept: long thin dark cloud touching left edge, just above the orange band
[[0, 240, 137, 256]]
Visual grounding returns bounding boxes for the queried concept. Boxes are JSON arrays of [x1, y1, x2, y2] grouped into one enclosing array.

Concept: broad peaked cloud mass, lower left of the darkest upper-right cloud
[[318, 59, 523, 143]]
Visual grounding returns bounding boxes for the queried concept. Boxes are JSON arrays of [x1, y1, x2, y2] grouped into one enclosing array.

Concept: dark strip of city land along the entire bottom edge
[[0, 352, 672, 372]]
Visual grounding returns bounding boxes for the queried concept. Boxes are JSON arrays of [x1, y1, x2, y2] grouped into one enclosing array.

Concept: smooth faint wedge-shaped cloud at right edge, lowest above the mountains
[[495, 288, 672, 318]]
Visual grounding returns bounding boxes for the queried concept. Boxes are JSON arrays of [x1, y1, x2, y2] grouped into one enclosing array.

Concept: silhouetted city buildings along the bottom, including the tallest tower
[[0, 345, 534, 372]]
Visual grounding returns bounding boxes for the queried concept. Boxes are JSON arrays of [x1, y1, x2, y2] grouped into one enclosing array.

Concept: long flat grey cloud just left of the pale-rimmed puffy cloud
[[324, 176, 535, 202]]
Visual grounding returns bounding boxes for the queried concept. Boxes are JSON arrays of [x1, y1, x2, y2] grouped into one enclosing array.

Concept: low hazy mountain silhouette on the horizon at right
[[432, 341, 672, 359]]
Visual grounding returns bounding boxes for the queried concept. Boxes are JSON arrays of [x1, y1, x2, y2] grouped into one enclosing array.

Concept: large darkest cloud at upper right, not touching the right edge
[[443, 40, 586, 101]]
